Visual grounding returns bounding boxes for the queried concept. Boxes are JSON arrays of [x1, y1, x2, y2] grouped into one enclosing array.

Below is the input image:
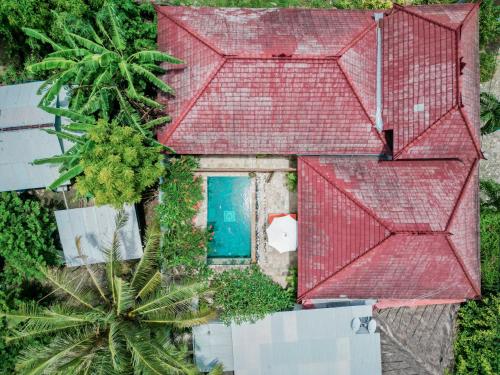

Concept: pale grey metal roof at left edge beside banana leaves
[[0, 82, 70, 191]]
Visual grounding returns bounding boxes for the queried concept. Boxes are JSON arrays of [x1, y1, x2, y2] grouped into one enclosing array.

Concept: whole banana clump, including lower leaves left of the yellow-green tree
[[23, 2, 182, 193]]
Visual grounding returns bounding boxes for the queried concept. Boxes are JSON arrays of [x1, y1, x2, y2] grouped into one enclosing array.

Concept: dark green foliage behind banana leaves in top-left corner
[[0, 0, 156, 83]]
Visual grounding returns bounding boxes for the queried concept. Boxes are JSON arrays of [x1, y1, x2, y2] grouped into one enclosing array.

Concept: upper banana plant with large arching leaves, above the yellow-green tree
[[23, 2, 183, 135]]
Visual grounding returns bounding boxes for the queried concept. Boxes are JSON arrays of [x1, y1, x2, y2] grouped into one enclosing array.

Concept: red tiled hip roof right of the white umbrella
[[298, 157, 480, 299]]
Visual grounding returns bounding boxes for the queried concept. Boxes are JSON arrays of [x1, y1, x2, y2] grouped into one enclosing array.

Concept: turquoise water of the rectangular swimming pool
[[207, 177, 251, 258]]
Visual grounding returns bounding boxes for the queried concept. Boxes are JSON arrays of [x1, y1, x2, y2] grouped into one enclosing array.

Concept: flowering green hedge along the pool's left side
[[156, 156, 212, 276]]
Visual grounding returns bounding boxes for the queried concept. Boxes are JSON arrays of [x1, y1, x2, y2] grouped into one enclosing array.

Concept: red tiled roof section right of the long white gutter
[[382, 4, 480, 159]]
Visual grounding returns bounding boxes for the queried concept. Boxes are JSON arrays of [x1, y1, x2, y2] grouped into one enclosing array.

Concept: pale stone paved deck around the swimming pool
[[195, 156, 297, 286]]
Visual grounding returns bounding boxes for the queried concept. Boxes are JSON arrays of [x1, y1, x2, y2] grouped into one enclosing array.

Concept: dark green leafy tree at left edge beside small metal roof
[[0, 192, 60, 285]]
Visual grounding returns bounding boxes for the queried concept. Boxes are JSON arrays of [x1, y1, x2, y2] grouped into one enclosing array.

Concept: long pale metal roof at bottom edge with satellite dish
[[193, 305, 382, 375]]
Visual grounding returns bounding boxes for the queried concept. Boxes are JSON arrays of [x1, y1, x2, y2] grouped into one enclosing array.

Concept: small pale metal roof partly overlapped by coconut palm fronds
[[55, 206, 142, 267]]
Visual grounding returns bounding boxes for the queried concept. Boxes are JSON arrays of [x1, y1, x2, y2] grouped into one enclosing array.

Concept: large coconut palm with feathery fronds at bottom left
[[1, 211, 215, 375]]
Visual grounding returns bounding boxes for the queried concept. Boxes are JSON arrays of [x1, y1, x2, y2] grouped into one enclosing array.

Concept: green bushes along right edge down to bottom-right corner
[[455, 181, 500, 375]]
